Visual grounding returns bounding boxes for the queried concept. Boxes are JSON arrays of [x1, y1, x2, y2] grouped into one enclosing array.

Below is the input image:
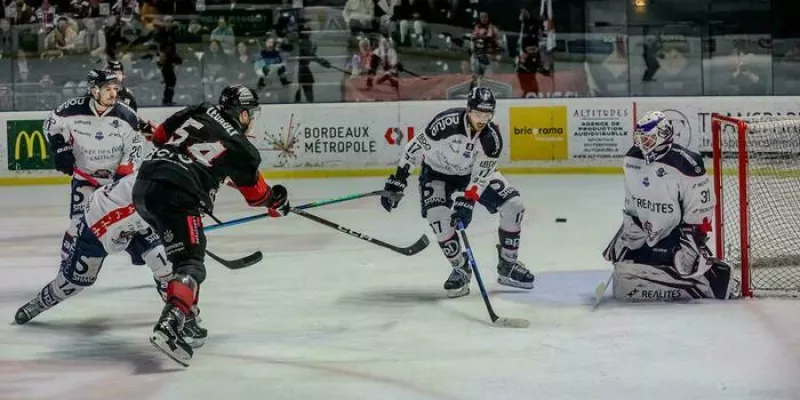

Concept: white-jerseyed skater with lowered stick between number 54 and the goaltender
[[381, 87, 534, 297]]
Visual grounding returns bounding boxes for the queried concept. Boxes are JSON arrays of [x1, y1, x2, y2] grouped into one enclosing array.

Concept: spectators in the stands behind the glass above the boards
[[0, 0, 800, 111]]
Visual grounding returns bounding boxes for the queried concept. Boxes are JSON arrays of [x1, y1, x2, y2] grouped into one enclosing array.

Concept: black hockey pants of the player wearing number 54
[[133, 179, 206, 284]]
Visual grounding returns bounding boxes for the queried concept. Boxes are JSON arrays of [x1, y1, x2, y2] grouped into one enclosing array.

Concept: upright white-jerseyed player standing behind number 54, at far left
[[44, 70, 144, 265]]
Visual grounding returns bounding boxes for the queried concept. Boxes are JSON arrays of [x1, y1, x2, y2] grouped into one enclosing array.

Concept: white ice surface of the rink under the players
[[0, 175, 800, 400]]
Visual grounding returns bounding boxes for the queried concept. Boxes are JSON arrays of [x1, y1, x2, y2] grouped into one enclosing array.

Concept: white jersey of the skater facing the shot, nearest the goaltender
[[399, 108, 503, 197]]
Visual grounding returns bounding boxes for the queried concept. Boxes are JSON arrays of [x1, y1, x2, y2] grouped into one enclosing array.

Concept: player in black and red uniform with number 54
[[133, 85, 289, 366]]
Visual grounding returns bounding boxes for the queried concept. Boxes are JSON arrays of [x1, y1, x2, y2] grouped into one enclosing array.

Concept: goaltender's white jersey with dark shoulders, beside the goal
[[624, 144, 716, 247]]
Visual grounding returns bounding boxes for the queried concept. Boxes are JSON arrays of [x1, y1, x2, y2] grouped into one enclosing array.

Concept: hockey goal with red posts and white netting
[[711, 114, 800, 296]]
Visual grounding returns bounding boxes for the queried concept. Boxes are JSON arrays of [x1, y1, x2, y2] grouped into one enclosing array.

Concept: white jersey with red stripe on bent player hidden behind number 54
[[84, 174, 155, 254]]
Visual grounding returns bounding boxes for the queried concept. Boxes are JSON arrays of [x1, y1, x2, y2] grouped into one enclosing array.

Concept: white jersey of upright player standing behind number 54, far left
[[44, 96, 143, 184]]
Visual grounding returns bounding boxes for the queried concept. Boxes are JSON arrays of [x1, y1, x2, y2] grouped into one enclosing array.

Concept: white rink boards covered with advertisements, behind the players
[[0, 97, 800, 185]]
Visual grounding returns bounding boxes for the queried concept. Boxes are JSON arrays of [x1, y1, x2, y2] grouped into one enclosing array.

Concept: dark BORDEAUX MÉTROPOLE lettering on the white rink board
[[303, 126, 375, 153]]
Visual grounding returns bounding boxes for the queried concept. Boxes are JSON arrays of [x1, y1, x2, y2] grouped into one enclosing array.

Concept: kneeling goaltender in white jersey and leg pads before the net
[[603, 111, 739, 300]]
